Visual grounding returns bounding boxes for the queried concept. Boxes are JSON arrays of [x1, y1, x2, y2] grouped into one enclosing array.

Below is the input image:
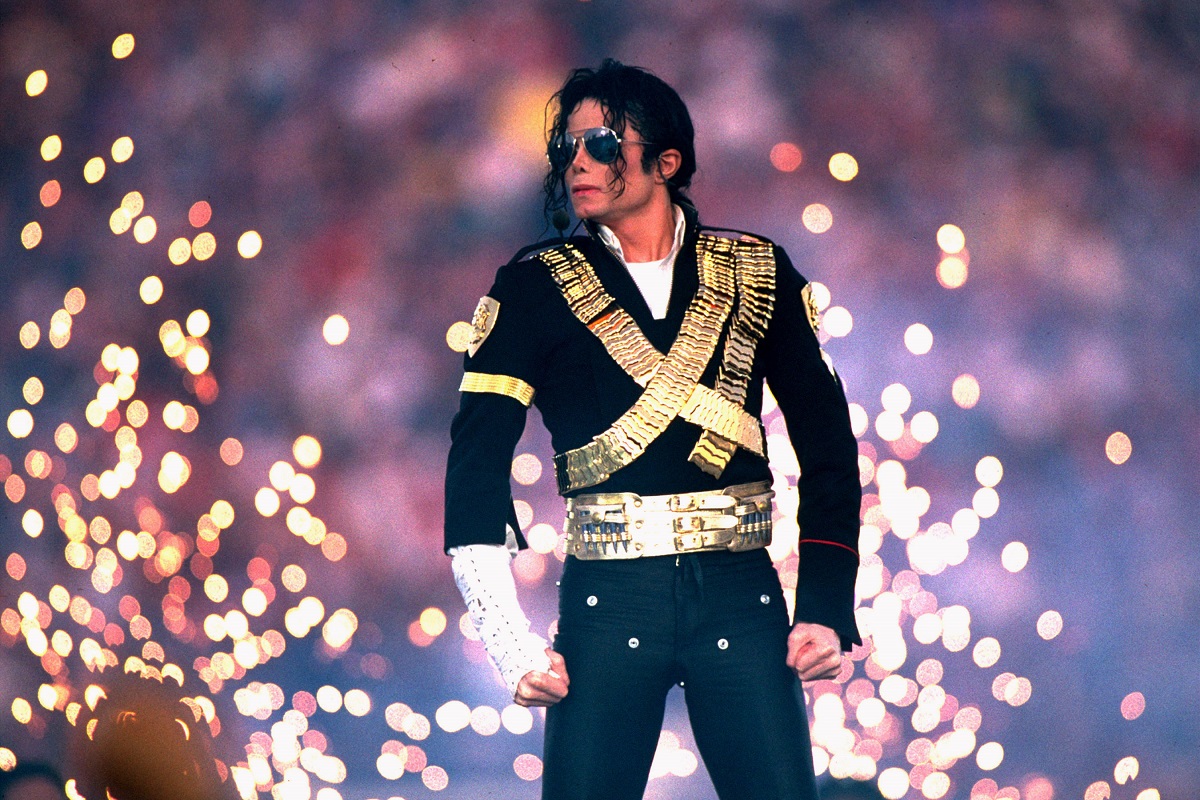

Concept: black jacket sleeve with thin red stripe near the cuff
[[763, 247, 862, 650]]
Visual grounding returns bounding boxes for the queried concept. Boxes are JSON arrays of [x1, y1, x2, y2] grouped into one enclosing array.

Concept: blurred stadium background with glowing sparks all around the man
[[0, 0, 1200, 800]]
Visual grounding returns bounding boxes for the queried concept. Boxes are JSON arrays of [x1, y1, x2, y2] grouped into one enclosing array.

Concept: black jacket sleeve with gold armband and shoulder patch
[[444, 264, 538, 549]]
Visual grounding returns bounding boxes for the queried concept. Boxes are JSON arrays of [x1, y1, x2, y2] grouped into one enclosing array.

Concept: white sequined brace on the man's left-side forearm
[[449, 534, 550, 693]]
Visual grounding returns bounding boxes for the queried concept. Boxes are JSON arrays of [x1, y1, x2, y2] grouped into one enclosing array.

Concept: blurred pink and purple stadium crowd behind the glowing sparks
[[0, 0, 1200, 800]]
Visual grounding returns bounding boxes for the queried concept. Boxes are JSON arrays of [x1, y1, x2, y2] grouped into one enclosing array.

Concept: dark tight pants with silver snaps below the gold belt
[[542, 549, 817, 800]]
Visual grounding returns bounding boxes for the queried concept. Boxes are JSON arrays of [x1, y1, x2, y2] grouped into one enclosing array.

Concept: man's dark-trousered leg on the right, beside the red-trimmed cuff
[[684, 559, 817, 800]]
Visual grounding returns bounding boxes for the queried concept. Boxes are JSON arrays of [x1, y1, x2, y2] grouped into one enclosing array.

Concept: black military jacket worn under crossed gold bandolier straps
[[445, 208, 862, 648]]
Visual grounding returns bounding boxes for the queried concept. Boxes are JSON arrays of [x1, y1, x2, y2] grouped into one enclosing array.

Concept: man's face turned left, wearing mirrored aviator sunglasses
[[563, 98, 668, 227]]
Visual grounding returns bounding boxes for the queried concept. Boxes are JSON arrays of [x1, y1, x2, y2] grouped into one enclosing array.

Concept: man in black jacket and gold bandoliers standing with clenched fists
[[445, 60, 860, 800]]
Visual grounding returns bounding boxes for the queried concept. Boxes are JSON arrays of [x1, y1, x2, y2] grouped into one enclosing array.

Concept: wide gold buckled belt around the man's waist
[[564, 481, 775, 560]]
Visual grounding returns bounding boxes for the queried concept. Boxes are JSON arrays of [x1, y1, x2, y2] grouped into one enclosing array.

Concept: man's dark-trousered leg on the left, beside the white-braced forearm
[[542, 563, 673, 800]]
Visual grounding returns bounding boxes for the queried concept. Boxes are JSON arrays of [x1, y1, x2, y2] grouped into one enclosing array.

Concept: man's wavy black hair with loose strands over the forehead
[[542, 59, 696, 223]]
